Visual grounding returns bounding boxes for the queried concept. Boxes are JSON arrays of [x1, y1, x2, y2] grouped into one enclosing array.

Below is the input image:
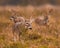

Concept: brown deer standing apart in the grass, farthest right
[[35, 15, 49, 25]]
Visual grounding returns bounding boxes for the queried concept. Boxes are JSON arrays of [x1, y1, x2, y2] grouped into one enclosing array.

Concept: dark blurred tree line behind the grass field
[[0, 0, 60, 5]]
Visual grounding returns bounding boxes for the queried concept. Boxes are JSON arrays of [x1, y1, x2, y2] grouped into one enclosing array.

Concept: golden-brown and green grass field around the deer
[[0, 5, 60, 48]]
